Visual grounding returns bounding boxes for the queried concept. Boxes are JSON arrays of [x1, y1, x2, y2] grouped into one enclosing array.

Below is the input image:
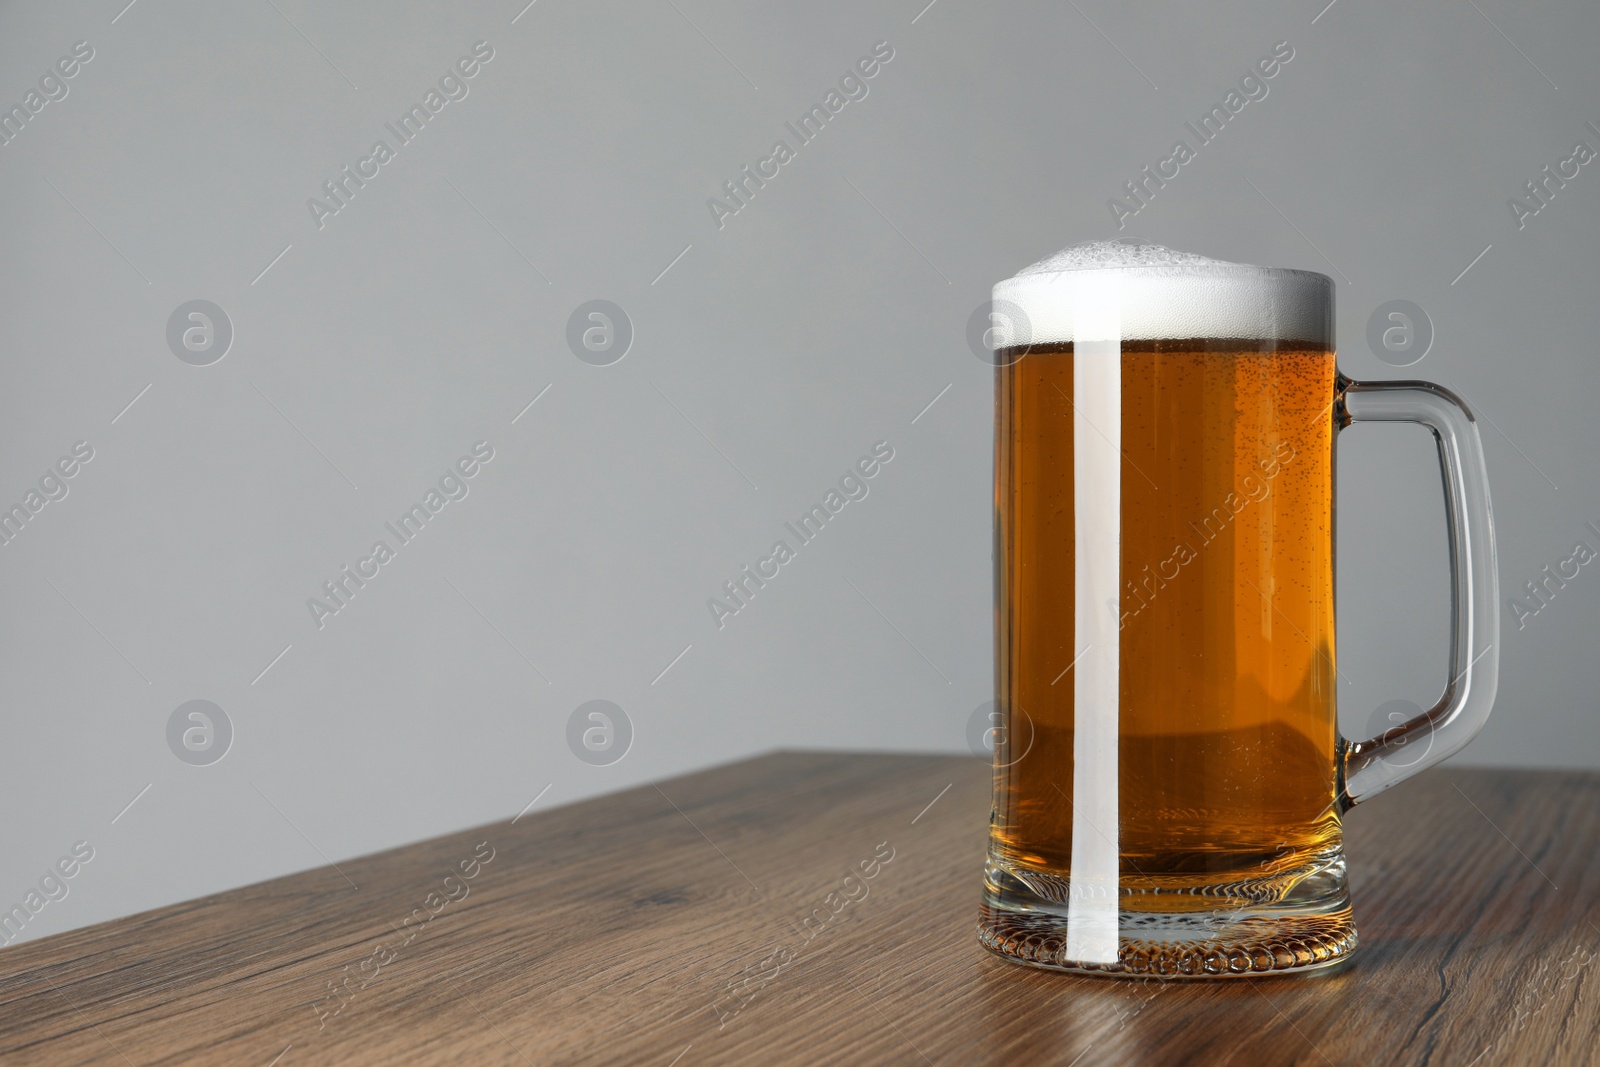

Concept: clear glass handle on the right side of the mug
[[1334, 376, 1499, 811]]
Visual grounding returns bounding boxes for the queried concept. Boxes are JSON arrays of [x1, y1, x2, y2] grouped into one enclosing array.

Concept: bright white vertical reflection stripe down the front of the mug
[[1067, 275, 1122, 963]]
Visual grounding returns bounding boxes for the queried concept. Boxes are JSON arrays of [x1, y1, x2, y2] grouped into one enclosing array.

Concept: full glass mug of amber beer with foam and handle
[[979, 242, 1498, 977]]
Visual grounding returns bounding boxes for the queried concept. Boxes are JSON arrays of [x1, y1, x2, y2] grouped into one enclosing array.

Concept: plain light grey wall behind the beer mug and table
[[0, 0, 1600, 937]]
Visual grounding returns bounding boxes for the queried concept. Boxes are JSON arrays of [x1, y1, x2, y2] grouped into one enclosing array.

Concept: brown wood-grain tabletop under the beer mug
[[0, 752, 1600, 1067]]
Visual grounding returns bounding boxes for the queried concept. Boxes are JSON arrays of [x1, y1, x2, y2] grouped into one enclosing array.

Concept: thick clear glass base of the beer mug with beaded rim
[[978, 853, 1357, 979]]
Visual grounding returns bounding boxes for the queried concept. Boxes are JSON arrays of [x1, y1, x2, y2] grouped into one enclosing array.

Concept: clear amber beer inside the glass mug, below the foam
[[994, 338, 1339, 895]]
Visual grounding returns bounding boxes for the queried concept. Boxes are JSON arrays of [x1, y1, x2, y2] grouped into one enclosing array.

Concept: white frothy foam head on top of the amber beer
[[992, 237, 1333, 349]]
